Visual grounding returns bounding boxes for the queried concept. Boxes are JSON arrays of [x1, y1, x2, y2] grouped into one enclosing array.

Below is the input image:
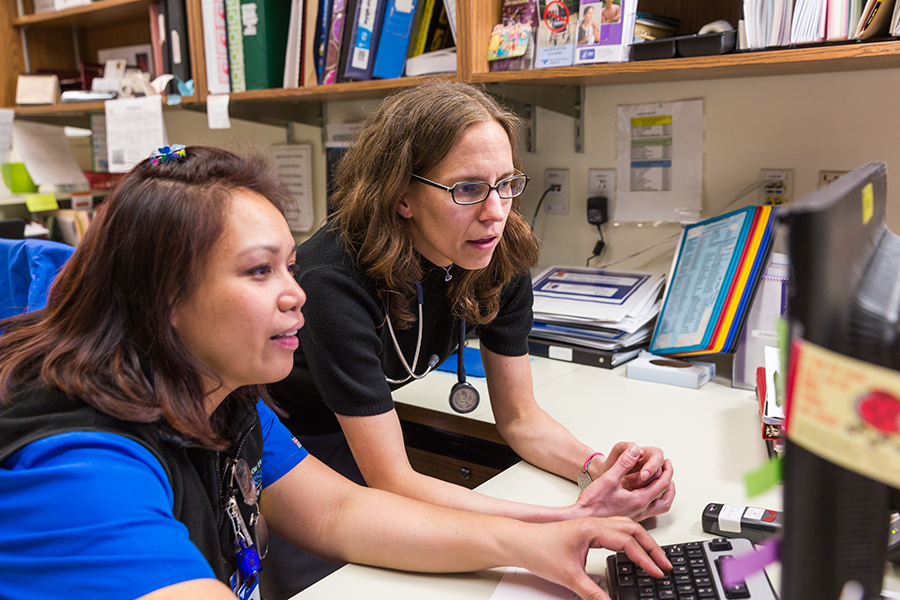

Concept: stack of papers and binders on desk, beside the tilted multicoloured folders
[[528, 266, 665, 369]]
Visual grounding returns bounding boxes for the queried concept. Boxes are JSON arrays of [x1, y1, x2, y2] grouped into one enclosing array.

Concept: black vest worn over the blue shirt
[[0, 387, 263, 584]]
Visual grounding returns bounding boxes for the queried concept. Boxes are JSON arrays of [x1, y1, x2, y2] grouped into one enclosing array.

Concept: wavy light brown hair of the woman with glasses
[[333, 79, 538, 327]]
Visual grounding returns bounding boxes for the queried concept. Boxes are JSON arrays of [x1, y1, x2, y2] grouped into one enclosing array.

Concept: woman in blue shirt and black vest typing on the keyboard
[[0, 146, 671, 600]]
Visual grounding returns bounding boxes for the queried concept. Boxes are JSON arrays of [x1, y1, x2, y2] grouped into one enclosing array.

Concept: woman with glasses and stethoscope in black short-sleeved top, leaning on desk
[[266, 80, 675, 598]]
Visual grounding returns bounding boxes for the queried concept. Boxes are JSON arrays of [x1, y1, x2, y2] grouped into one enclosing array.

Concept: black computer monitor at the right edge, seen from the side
[[779, 163, 900, 600]]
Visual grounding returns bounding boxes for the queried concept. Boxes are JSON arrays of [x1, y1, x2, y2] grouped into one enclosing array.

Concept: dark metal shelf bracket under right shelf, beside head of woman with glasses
[[484, 83, 585, 153]]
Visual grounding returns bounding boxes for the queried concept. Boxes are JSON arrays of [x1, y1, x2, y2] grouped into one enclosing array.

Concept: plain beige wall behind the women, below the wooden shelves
[[158, 69, 900, 271]]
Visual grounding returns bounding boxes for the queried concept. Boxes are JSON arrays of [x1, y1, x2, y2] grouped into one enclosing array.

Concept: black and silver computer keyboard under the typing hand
[[606, 538, 778, 600]]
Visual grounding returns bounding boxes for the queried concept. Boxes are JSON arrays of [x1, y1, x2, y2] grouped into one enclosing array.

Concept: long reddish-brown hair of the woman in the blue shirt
[[0, 146, 288, 448]]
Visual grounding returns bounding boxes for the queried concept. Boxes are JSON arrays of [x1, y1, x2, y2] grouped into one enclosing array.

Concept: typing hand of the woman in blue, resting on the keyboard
[[522, 517, 672, 600]]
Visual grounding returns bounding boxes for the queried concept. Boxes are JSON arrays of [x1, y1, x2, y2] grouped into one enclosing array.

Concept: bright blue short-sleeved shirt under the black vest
[[0, 402, 307, 600]]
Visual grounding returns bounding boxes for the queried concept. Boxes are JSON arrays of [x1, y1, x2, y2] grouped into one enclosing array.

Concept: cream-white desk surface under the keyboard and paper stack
[[295, 358, 900, 600]]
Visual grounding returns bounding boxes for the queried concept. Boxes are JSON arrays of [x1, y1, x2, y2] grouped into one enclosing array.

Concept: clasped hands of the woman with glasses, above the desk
[[576, 442, 675, 521]]
